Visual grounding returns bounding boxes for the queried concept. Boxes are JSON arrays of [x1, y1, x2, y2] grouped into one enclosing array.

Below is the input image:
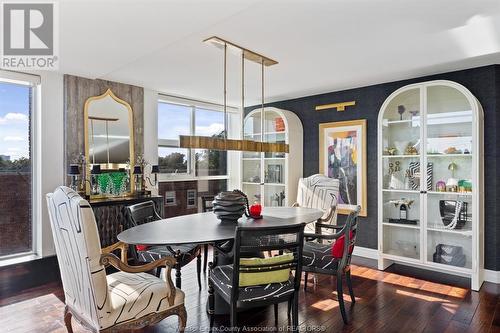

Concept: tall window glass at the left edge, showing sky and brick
[[0, 74, 36, 257]]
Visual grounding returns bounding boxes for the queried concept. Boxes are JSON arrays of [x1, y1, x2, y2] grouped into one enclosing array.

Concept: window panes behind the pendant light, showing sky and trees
[[158, 100, 234, 177]]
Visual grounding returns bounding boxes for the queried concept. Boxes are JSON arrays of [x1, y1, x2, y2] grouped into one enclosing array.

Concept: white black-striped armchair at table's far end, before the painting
[[295, 174, 339, 234]]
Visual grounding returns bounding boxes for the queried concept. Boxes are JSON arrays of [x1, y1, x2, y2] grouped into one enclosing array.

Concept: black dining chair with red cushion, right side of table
[[302, 206, 360, 324]]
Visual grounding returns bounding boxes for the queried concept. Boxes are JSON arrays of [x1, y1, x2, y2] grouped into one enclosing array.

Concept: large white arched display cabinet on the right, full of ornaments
[[378, 80, 484, 290]]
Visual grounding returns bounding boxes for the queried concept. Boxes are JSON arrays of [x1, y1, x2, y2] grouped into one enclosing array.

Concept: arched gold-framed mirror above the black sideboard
[[84, 89, 135, 198]]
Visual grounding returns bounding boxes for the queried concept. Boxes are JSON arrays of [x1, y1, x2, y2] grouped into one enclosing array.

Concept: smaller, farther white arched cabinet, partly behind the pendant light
[[241, 107, 303, 206]]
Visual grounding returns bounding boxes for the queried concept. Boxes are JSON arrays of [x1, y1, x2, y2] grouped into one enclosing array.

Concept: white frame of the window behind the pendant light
[[156, 94, 241, 182]]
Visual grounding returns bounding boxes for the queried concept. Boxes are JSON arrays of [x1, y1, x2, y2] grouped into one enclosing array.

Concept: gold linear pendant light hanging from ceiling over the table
[[179, 36, 289, 153]]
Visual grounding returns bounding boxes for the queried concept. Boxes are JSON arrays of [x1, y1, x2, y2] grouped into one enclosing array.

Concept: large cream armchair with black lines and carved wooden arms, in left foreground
[[47, 186, 186, 333]]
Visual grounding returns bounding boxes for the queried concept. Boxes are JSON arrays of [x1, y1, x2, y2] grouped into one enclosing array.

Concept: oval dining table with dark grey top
[[117, 207, 323, 314]]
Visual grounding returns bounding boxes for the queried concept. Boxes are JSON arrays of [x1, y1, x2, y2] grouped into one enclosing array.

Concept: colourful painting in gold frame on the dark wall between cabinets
[[319, 119, 367, 216]]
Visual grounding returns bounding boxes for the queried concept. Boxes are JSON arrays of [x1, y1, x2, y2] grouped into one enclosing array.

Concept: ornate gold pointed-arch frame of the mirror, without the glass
[[83, 88, 135, 198]]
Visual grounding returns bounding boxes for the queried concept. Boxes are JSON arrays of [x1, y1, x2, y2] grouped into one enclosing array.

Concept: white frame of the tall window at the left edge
[[0, 70, 42, 266]]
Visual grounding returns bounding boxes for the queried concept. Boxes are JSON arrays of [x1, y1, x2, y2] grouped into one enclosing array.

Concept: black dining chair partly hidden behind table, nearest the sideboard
[[127, 201, 201, 290]]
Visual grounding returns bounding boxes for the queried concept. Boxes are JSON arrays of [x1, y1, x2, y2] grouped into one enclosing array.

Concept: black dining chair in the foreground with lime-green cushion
[[208, 224, 304, 331]]
